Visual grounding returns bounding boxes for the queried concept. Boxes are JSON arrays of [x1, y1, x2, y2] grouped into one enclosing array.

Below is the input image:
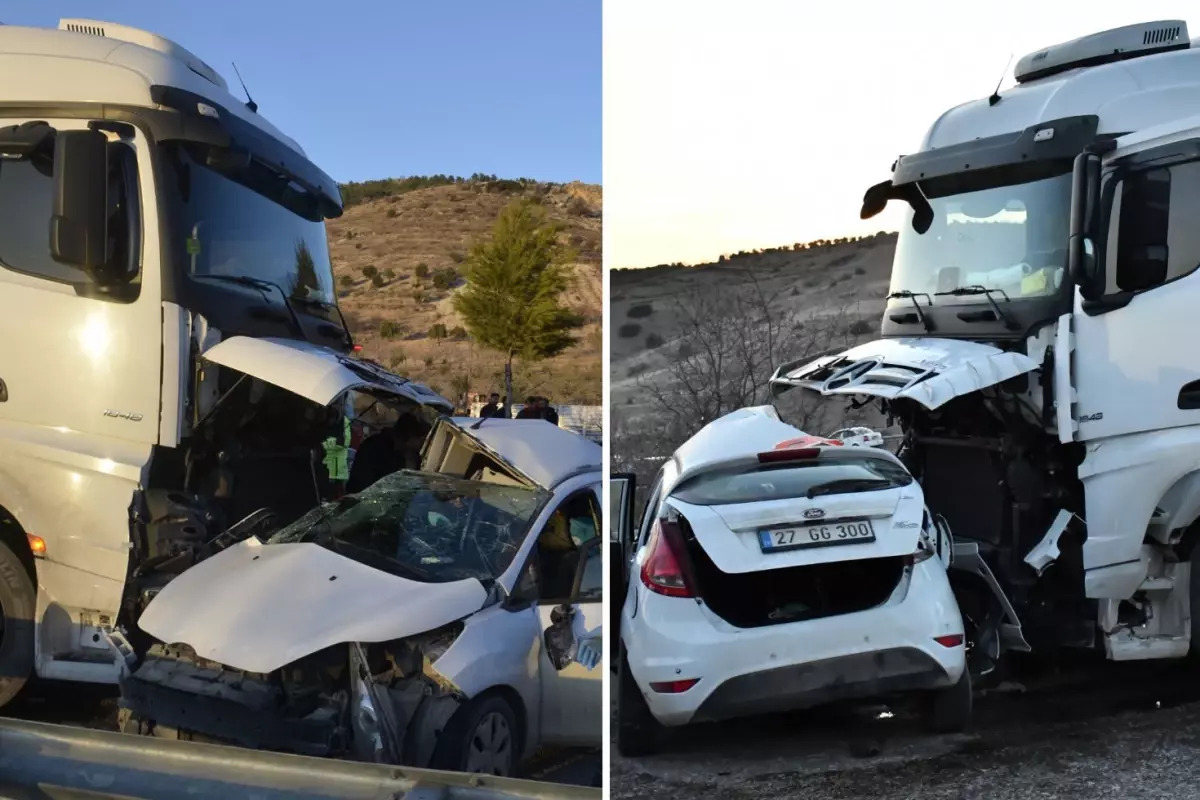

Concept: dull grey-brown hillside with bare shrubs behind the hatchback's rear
[[610, 234, 896, 499]]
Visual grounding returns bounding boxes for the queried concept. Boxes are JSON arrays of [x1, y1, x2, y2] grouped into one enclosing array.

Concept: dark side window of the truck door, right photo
[[1108, 162, 1200, 293]]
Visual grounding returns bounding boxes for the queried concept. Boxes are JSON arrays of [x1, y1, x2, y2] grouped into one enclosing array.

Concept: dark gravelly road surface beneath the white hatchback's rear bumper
[[610, 663, 1200, 800]]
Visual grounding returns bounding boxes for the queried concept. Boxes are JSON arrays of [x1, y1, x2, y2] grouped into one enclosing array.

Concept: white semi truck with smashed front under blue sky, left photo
[[0, 19, 450, 704]]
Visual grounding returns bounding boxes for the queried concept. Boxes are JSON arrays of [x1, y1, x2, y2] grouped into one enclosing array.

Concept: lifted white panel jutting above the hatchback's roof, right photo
[[770, 338, 1038, 410]]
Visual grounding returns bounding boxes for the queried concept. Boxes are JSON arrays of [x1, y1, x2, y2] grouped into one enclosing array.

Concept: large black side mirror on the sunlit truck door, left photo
[[50, 130, 108, 277]]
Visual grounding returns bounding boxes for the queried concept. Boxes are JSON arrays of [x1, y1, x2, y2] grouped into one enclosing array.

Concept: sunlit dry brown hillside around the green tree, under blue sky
[[328, 180, 602, 403]]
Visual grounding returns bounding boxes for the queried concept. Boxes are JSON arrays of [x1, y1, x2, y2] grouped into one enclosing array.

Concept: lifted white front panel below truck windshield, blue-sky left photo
[[203, 336, 454, 411]]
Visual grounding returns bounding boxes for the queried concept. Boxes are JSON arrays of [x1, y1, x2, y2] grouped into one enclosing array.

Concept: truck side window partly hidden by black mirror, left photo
[[0, 133, 142, 291]]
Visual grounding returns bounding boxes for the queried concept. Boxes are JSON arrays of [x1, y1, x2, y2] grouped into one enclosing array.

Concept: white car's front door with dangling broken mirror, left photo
[[536, 487, 604, 747]]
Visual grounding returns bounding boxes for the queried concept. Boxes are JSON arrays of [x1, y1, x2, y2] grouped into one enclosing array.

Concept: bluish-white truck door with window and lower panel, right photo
[[1070, 136, 1200, 587]]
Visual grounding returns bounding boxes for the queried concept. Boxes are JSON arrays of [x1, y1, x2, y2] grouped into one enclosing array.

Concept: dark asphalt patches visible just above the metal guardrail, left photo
[[4, 682, 601, 786]]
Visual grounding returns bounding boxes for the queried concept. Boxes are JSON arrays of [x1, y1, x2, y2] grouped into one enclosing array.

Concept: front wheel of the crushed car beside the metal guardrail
[[430, 694, 521, 777]]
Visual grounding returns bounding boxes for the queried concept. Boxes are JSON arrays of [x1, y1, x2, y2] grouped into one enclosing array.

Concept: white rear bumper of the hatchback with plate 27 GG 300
[[622, 560, 966, 726]]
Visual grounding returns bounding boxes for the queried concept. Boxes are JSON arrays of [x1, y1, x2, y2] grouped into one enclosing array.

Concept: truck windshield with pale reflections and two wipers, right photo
[[889, 172, 1072, 303]]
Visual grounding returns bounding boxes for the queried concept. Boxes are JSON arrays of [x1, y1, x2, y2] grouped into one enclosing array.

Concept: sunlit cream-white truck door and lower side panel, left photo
[[0, 116, 162, 623]]
